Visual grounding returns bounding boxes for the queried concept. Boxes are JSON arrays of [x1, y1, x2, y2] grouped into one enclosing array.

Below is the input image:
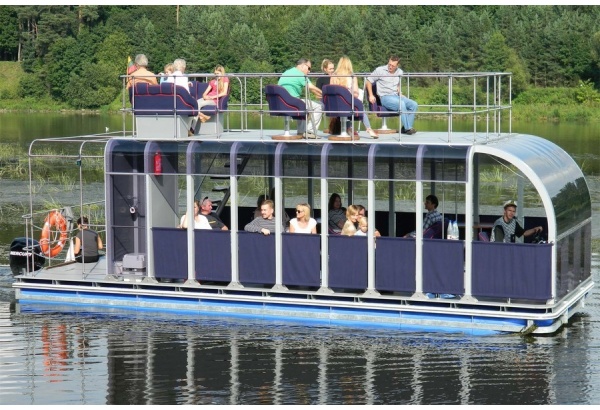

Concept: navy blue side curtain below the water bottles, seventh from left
[[423, 239, 465, 295]]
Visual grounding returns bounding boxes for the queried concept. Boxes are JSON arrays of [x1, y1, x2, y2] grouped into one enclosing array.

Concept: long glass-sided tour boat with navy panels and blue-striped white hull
[[13, 69, 594, 334]]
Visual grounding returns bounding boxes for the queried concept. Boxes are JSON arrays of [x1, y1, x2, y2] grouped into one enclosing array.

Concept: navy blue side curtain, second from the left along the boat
[[194, 229, 231, 282]]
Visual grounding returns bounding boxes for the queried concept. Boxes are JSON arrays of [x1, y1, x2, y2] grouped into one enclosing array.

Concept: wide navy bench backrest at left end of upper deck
[[129, 82, 198, 116]]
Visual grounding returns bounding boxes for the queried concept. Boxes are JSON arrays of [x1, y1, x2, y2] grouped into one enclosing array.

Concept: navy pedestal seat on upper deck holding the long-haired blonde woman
[[323, 84, 365, 141]]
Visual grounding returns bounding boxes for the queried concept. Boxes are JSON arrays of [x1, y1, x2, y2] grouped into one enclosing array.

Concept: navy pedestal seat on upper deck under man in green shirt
[[265, 84, 306, 140]]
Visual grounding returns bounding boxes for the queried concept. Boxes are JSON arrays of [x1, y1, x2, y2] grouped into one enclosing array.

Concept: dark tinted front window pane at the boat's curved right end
[[552, 176, 592, 232]]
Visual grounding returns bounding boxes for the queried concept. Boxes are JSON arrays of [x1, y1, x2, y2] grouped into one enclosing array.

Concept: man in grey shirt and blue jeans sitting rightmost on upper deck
[[365, 56, 419, 135]]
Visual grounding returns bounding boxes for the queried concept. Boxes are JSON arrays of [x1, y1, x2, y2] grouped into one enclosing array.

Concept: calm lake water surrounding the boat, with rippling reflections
[[0, 114, 600, 405]]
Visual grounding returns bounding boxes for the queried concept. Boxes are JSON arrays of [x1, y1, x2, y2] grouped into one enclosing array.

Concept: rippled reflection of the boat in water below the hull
[[13, 304, 590, 405]]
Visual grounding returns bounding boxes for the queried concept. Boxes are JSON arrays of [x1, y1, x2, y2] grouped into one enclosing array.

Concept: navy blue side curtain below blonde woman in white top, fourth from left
[[282, 233, 321, 287]]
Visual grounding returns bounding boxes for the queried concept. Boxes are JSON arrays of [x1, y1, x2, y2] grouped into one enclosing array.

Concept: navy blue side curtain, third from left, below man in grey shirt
[[238, 232, 275, 285]]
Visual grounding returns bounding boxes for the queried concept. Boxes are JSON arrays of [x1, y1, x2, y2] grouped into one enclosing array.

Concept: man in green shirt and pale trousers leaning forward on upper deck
[[278, 58, 323, 138]]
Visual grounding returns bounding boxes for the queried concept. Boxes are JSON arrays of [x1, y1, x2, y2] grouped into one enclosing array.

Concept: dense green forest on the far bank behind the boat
[[0, 5, 600, 121]]
